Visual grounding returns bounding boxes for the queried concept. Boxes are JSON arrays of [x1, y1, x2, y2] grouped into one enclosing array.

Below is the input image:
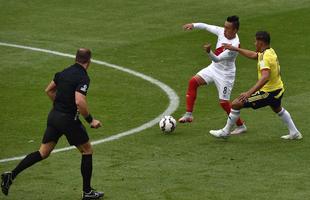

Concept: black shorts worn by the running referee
[[42, 109, 89, 146]]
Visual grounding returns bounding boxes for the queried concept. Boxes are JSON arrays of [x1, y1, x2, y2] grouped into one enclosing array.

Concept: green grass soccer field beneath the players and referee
[[0, 0, 310, 200]]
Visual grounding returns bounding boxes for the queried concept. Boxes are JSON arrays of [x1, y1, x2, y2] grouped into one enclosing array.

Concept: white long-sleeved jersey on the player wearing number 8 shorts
[[193, 23, 240, 76]]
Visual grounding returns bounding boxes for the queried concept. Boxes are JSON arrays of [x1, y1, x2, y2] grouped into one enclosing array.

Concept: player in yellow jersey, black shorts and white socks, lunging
[[210, 31, 302, 140]]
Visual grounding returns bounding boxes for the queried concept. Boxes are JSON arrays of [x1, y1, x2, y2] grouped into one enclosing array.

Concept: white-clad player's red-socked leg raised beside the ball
[[179, 75, 206, 123]]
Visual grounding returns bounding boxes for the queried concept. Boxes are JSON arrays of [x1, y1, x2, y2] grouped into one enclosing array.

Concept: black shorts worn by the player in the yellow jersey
[[243, 89, 284, 109]]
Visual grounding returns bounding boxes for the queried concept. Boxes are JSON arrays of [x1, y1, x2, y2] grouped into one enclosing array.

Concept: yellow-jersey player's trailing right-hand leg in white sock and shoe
[[271, 99, 302, 140]]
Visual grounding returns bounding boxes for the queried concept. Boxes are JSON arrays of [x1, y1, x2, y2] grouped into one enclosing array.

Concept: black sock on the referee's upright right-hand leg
[[81, 154, 93, 192]]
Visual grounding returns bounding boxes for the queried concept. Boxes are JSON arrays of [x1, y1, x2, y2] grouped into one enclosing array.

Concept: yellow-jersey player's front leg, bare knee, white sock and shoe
[[210, 98, 244, 138]]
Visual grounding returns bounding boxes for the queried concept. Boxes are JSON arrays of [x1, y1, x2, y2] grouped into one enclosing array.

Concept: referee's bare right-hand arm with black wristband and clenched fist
[[75, 92, 101, 128]]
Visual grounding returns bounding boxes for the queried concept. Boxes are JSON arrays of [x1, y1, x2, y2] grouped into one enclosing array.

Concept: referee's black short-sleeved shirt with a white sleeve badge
[[54, 63, 90, 115]]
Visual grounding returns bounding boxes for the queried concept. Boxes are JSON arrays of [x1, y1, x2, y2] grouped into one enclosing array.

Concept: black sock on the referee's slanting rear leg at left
[[12, 151, 42, 179]]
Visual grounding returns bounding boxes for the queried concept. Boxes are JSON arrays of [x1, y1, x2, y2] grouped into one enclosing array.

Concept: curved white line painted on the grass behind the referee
[[0, 42, 179, 163]]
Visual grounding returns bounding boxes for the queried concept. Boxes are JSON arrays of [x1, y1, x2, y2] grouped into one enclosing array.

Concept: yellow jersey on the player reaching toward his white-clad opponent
[[257, 48, 284, 92]]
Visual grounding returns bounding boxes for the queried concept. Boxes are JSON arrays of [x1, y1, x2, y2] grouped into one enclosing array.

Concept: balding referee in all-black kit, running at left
[[1, 48, 104, 200]]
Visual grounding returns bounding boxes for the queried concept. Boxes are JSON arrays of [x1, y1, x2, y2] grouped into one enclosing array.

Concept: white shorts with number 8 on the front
[[197, 64, 235, 100]]
